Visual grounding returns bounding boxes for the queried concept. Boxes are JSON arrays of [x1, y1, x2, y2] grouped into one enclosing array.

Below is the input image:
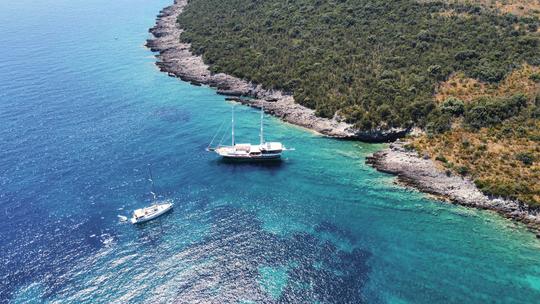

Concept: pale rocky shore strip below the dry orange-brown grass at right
[[366, 141, 540, 237]]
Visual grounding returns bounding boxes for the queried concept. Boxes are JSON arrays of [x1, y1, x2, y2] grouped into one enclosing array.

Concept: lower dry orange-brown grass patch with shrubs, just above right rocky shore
[[411, 119, 540, 205]]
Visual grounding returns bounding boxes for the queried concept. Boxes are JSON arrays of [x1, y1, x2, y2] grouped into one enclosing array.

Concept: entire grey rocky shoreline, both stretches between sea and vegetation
[[146, 0, 540, 237]]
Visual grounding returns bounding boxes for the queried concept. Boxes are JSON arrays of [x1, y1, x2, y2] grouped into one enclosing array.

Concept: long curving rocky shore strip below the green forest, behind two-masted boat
[[146, 0, 408, 142]]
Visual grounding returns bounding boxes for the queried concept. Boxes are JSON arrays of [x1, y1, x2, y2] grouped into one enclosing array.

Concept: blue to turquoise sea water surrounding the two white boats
[[0, 0, 540, 303]]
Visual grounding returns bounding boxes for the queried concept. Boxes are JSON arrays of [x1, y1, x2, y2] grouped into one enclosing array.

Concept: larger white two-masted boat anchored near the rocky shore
[[206, 107, 294, 161]]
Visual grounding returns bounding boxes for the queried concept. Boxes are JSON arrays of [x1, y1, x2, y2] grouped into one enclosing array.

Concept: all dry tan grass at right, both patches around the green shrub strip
[[411, 65, 540, 206]]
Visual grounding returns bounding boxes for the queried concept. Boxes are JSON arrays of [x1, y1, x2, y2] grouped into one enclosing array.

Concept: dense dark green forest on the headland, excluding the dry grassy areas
[[179, 0, 540, 129]]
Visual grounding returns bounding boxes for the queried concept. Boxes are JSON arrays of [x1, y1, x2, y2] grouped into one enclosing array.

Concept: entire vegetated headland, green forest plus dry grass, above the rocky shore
[[179, 0, 540, 206]]
